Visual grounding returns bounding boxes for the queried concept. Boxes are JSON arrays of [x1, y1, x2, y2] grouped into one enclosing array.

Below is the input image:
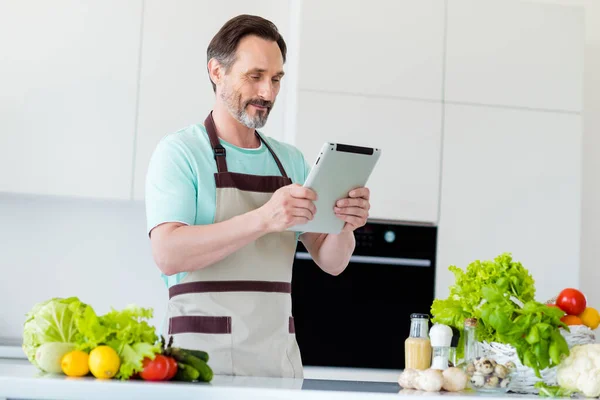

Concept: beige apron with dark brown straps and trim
[[168, 113, 303, 378]]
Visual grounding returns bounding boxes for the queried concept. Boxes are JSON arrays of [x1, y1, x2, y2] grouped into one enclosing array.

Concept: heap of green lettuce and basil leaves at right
[[431, 253, 569, 377]]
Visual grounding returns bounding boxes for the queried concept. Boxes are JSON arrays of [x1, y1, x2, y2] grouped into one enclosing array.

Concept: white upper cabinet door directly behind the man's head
[[134, 0, 290, 200]]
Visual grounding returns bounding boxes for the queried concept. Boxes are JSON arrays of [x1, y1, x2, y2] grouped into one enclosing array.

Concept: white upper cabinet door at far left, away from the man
[[0, 0, 142, 199]]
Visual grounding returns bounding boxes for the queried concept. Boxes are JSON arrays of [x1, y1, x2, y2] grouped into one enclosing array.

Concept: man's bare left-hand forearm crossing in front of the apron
[[152, 212, 266, 275]]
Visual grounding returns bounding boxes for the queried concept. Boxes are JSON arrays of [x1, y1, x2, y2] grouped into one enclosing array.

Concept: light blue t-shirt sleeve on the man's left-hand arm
[[146, 137, 197, 234]]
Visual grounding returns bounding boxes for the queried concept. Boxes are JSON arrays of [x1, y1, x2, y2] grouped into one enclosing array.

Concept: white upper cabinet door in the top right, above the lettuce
[[445, 0, 585, 112]]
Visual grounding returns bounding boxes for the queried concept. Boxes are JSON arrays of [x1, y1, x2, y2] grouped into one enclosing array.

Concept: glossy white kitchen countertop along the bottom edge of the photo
[[0, 359, 539, 400]]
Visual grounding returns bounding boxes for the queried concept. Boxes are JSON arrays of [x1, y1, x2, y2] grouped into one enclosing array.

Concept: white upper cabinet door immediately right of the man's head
[[298, 0, 445, 100]]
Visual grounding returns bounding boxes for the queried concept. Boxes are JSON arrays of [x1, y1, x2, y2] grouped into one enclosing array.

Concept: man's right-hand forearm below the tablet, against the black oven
[[305, 232, 356, 275]]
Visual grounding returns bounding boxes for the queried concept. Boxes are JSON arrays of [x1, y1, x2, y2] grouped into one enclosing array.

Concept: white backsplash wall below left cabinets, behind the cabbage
[[0, 194, 168, 338]]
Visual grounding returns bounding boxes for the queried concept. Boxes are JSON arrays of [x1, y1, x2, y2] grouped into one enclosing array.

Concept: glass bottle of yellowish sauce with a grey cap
[[404, 314, 431, 370]]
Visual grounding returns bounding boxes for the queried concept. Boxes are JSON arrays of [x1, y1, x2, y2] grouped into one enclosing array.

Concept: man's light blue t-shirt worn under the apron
[[146, 124, 310, 287]]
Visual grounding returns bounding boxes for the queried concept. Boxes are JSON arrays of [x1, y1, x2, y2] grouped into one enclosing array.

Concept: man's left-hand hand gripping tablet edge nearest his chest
[[257, 183, 317, 232]]
